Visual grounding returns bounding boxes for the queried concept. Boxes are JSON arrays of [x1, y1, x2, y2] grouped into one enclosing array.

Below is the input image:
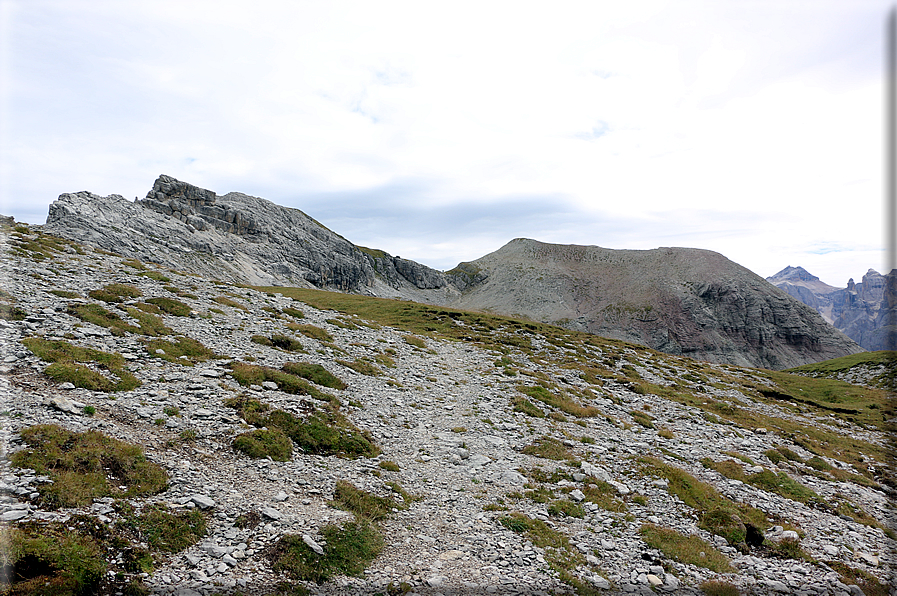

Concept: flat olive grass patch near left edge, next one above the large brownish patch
[[22, 337, 140, 392]]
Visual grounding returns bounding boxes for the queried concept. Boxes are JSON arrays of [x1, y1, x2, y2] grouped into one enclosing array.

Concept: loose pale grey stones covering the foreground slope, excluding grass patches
[[0, 225, 897, 596]]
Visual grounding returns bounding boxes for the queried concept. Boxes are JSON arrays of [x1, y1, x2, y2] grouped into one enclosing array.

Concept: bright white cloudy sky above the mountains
[[0, 0, 890, 286]]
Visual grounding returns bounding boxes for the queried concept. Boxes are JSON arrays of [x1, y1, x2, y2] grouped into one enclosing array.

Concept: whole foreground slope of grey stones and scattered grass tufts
[[0, 220, 897, 596]]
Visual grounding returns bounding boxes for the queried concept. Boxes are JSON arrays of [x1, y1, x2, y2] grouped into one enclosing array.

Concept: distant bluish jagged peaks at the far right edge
[[766, 266, 897, 351]]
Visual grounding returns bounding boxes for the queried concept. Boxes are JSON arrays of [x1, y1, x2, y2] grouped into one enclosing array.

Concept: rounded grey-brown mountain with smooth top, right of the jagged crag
[[455, 239, 862, 368]]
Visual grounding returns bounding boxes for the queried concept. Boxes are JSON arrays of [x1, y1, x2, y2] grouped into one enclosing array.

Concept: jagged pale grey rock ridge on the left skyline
[[46, 175, 457, 302]]
